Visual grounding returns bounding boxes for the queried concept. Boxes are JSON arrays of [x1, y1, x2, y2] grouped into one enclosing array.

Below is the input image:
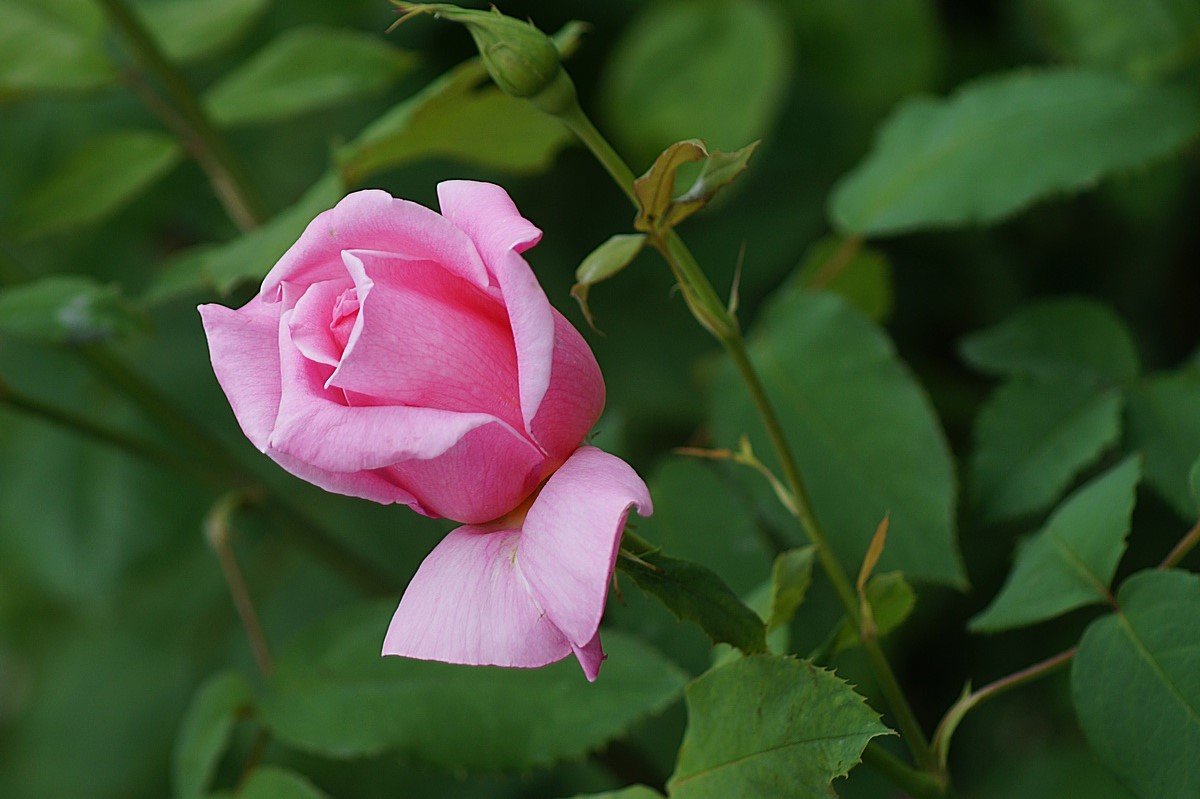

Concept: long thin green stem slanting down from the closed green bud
[[559, 103, 936, 769]]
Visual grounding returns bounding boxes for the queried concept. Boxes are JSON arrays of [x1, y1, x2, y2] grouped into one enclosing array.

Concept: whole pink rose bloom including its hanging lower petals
[[199, 181, 652, 679]]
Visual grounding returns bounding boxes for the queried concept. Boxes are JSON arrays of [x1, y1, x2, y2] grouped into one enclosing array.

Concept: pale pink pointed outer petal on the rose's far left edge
[[199, 296, 281, 452]]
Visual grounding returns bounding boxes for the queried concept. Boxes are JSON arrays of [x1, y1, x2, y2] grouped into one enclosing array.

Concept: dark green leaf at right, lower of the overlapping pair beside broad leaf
[[971, 377, 1122, 522]]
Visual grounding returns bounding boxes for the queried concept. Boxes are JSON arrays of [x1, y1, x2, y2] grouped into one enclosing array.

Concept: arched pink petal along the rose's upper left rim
[[260, 190, 488, 302]]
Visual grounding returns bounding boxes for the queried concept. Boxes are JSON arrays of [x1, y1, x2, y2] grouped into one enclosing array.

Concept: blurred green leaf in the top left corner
[[0, 0, 116, 98]]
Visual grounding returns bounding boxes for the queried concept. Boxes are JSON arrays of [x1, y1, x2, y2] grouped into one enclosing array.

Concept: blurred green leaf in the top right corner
[[1030, 0, 1200, 79]]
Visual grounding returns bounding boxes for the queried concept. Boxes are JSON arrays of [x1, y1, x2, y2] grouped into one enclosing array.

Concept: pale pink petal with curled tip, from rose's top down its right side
[[438, 180, 554, 429]]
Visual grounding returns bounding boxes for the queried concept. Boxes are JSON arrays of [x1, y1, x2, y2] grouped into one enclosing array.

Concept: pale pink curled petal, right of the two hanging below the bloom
[[518, 446, 653, 662]]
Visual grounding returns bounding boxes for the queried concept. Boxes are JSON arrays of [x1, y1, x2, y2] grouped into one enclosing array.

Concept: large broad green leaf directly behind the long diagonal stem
[[713, 287, 965, 585]]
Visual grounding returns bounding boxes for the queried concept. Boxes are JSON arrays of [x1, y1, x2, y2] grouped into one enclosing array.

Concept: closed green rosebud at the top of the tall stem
[[392, 0, 575, 114]]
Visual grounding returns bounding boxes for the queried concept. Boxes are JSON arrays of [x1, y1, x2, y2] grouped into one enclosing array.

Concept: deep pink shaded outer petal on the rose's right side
[[532, 311, 605, 462]]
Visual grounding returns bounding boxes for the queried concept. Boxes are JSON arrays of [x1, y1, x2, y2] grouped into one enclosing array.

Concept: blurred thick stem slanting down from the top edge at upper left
[[101, 0, 265, 230]]
